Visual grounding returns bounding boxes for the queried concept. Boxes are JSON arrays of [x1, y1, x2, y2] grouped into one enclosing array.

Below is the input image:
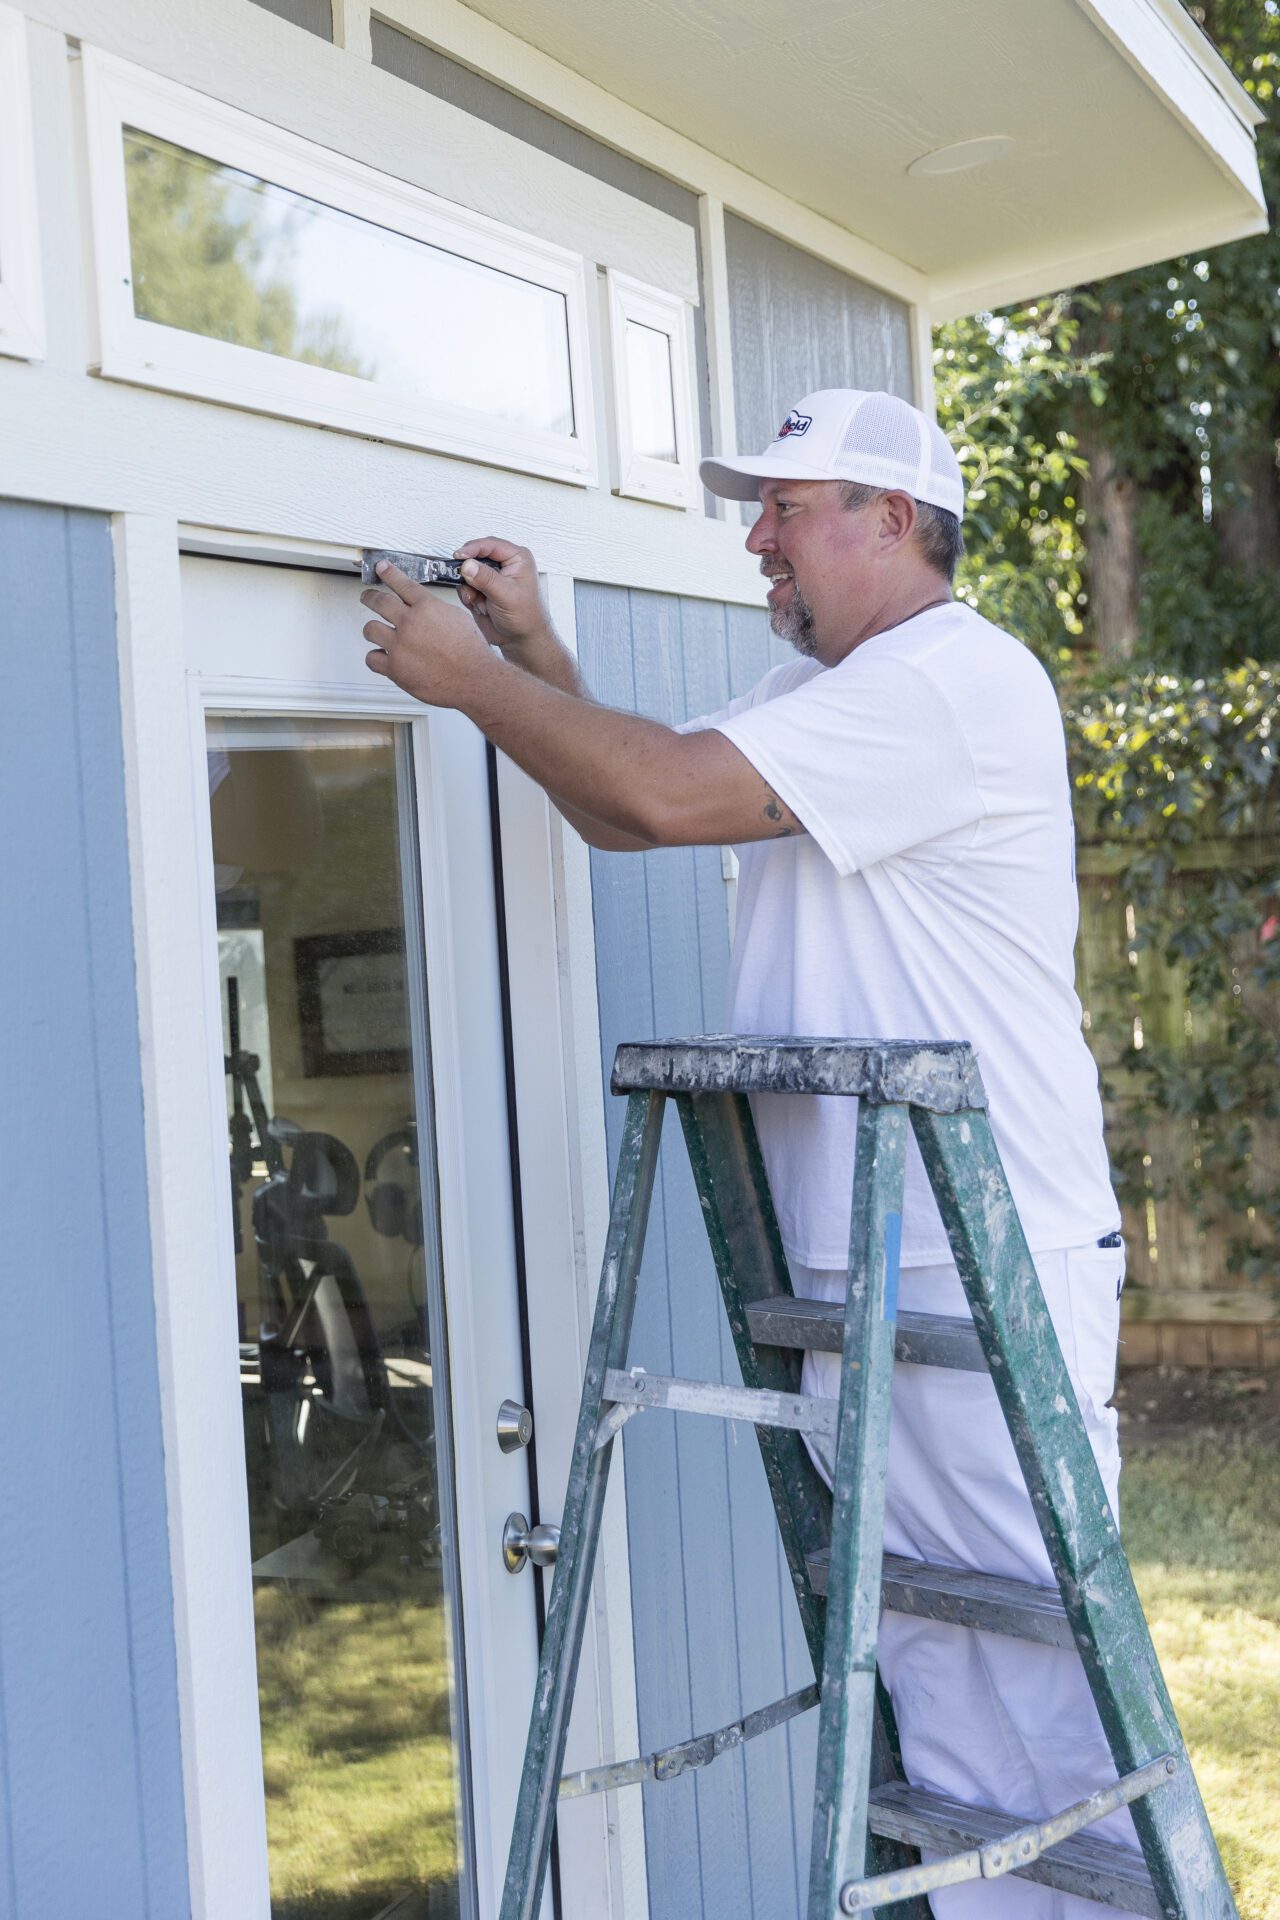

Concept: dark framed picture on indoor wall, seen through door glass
[[294, 927, 411, 1079]]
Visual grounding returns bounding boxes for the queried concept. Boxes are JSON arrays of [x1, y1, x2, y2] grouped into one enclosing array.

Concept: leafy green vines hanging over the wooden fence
[[1065, 662, 1280, 1284]]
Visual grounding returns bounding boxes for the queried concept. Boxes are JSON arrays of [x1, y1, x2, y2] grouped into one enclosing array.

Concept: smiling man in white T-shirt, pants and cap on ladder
[[365, 388, 1132, 1920]]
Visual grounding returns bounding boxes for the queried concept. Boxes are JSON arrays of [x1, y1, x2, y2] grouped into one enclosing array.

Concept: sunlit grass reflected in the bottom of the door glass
[[255, 1584, 457, 1920]]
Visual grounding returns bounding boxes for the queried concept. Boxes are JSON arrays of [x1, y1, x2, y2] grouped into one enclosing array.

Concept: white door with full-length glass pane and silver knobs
[[182, 557, 535, 1920]]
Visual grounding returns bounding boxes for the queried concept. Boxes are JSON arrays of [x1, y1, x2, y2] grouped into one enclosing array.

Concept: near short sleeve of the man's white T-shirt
[[714, 657, 984, 874]]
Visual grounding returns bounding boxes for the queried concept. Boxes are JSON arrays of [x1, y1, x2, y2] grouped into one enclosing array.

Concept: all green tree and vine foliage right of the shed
[[935, 0, 1280, 1281]]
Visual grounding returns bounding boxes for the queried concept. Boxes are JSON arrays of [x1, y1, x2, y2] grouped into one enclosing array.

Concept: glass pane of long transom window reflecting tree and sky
[[125, 127, 574, 434]]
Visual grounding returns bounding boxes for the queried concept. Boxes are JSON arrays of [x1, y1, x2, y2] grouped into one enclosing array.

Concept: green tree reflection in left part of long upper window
[[125, 132, 365, 374]]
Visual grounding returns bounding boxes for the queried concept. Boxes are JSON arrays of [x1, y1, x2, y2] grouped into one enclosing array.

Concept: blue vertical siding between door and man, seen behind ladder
[[576, 586, 816, 1920]]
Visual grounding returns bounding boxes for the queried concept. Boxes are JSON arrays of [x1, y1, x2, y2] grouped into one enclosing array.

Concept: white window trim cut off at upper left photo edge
[[0, 6, 44, 359]]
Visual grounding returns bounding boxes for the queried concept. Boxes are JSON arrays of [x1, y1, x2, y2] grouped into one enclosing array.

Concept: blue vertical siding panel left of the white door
[[0, 501, 188, 1920]]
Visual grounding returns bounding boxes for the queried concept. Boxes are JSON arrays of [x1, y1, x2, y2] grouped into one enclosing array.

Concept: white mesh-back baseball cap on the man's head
[[700, 386, 965, 518]]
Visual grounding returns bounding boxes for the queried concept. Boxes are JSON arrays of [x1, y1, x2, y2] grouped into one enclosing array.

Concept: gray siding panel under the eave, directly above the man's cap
[[725, 213, 915, 464]]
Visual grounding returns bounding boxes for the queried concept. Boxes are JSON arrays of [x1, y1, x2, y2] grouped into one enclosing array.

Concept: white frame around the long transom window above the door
[[83, 48, 597, 486]]
